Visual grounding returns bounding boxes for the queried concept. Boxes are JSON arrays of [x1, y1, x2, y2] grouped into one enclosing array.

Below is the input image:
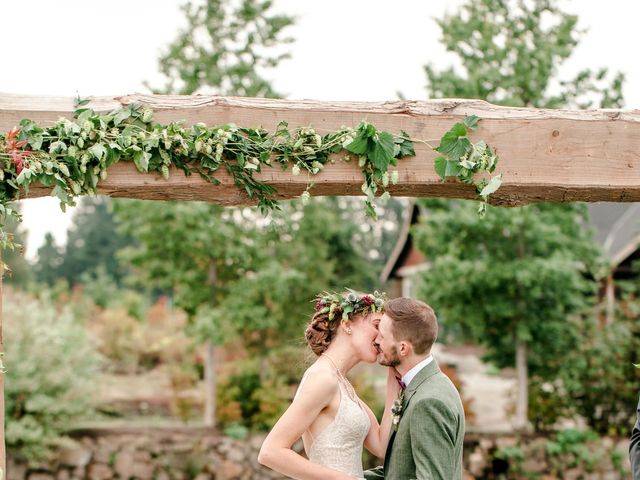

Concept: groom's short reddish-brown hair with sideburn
[[384, 297, 438, 355]]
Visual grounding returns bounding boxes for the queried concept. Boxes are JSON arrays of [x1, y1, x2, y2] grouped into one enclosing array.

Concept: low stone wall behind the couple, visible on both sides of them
[[7, 428, 629, 480]]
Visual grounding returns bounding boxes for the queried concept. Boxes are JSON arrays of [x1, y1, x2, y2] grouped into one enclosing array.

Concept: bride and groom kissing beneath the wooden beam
[[258, 291, 464, 480]]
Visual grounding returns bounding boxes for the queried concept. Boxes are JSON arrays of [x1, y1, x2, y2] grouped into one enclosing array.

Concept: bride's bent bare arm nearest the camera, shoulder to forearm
[[258, 370, 353, 480]]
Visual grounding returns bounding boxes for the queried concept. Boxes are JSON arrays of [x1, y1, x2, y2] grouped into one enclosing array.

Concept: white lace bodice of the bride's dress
[[307, 380, 371, 479]]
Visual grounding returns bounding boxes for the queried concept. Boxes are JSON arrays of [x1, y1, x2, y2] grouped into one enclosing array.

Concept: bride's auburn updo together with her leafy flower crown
[[304, 290, 386, 356]]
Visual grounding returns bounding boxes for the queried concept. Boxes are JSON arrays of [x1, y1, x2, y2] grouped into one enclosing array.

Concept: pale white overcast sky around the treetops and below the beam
[[0, 0, 640, 256]]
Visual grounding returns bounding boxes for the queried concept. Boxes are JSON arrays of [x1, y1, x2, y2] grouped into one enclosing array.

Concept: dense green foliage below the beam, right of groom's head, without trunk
[[414, 201, 599, 378]]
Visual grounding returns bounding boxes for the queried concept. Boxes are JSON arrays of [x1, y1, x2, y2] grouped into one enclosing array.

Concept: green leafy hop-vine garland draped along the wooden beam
[[0, 98, 501, 262]]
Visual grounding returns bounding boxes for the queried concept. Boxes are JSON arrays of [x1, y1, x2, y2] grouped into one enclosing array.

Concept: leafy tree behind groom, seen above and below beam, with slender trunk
[[416, 0, 624, 423]]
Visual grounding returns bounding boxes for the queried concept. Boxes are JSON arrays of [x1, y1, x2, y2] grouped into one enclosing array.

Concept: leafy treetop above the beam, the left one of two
[[147, 0, 293, 97]]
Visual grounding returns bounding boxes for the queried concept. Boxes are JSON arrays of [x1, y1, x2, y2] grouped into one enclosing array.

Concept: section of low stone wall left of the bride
[[7, 428, 284, 480]]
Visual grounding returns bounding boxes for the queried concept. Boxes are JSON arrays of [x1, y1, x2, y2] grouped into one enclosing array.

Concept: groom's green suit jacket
[[365, 359, 464, 480]]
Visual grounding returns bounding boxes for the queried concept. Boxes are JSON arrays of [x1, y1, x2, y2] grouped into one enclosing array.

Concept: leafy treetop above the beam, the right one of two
[[425, 0, 624, 108]]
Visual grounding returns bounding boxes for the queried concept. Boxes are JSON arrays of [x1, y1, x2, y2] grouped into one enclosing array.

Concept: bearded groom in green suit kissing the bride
[[365, 298, 464, 480]]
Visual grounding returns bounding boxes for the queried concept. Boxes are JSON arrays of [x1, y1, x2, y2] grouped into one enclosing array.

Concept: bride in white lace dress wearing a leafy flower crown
[[258, 291, 399, 480]]
